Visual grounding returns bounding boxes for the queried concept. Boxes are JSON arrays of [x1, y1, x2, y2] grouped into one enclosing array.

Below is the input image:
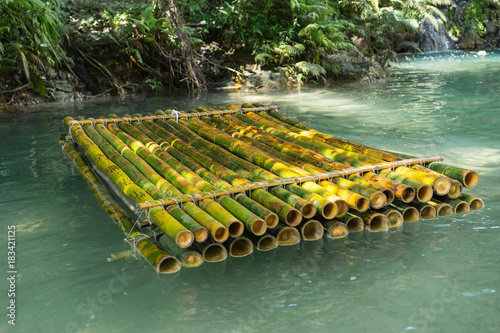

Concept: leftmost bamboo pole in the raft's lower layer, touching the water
[[59, 139, 180, 273]]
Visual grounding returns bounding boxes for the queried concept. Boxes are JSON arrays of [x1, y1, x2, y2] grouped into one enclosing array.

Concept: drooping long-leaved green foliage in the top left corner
[[0, 0, 66, 95]]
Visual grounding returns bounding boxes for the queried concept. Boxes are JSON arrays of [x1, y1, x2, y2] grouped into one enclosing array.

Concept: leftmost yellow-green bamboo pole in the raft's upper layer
[[64, 117, 194, 248]]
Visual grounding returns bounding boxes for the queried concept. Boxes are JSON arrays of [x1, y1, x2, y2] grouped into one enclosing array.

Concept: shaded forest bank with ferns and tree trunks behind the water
[[0, 0, 500, 108]]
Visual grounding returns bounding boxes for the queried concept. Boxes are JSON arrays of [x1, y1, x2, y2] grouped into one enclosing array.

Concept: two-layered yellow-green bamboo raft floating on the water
[[60, 104, 484, 273]]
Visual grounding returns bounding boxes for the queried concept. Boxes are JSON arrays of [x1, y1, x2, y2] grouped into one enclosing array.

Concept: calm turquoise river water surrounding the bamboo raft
[[0, 52, 500, 332]]
